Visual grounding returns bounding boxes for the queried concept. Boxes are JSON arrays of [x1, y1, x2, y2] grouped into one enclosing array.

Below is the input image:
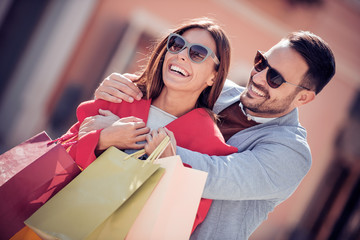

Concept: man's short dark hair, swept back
[[284, 31, 335, 94]]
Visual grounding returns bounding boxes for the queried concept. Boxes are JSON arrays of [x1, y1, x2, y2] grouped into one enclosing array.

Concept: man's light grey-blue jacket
[[177, 81, 311, 240]]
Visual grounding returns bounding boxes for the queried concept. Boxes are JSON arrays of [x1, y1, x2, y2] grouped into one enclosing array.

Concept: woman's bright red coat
[[60, 100, 237, 230]]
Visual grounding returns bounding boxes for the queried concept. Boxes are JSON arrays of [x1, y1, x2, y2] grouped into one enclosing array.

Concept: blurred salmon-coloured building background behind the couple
[[0, 0, 360, 240]]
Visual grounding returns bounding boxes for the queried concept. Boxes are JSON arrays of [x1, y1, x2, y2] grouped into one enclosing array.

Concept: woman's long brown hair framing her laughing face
[[136, 18, 231, 110]]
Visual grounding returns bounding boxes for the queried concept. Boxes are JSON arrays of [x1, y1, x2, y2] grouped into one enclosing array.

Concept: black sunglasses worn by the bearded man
[[254, 51, 309, 90]]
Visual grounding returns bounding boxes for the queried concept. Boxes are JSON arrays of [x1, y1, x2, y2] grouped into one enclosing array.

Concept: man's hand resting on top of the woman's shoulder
[[95, 73, 143, 103]]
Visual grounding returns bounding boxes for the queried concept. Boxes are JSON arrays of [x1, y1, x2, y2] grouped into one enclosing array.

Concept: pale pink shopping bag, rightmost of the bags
[[126, 156, 207, 240]]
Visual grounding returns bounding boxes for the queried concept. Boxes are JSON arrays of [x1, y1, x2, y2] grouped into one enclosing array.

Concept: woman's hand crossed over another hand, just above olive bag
[[97, 117, 150, 150]]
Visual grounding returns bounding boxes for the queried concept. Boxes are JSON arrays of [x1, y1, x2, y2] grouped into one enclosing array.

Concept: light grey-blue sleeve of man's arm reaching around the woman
[[177, 135, 311, 200]]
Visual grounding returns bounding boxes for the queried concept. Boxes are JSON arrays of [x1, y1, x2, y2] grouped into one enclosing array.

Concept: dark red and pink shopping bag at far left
[[0, 132, 80, 239]]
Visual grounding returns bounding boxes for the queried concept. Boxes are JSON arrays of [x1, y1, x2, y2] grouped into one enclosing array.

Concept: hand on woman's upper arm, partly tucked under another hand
[[79, 109, 119, 138]]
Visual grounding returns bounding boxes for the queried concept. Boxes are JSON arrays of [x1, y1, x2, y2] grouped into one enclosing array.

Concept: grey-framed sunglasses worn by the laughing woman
[[166, 33, 220, 65]]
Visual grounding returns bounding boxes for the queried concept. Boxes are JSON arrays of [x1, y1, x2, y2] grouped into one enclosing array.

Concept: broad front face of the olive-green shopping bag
[[25, 137, 169, 239]]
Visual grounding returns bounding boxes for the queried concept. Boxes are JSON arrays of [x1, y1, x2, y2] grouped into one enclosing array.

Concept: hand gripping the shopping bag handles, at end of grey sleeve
[[145, 128, 176, 157]]
